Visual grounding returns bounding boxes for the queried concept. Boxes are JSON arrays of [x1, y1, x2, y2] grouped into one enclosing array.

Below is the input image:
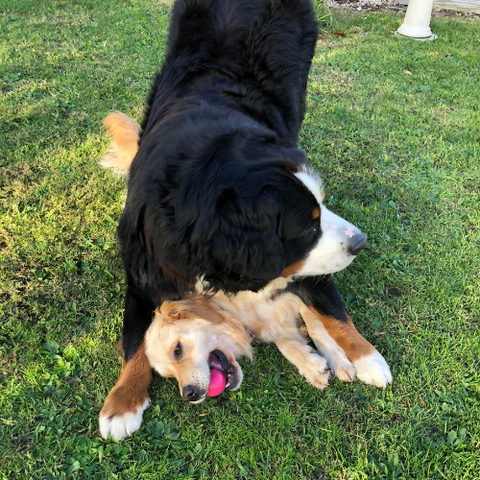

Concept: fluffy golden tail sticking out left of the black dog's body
[[100, 112, 140, 175]]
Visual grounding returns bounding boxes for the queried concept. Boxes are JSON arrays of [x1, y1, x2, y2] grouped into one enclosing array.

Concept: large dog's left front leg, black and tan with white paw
[[99, 286, 153, 441]]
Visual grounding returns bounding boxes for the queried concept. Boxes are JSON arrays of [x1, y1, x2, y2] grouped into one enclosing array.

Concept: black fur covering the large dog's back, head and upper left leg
[[117, 0, 352, 361]]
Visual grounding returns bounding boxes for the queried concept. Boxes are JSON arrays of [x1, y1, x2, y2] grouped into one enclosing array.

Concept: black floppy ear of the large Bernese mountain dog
[[203, 188, 285, 292]]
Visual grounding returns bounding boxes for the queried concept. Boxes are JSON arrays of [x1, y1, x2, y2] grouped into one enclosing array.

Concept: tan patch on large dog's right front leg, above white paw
[[309, 307, 376, 362]]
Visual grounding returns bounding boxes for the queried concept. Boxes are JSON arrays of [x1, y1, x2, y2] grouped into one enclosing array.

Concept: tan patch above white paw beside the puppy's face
[[100, 343, 153, 417]]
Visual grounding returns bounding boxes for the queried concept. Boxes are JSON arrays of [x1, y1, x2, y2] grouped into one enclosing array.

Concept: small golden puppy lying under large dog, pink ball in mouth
[[145, 278, 391, 403]]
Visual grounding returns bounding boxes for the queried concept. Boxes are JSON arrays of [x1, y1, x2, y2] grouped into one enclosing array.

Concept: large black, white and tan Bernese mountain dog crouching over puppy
[[100, 0, 391, 439]]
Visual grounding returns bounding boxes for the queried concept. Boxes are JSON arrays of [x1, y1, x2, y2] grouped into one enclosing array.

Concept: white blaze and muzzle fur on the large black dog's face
[[295, 170, 364, 276]]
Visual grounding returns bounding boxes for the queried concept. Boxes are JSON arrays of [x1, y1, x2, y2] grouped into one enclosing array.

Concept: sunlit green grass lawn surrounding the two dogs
[[0, 0, 480, 480]]
